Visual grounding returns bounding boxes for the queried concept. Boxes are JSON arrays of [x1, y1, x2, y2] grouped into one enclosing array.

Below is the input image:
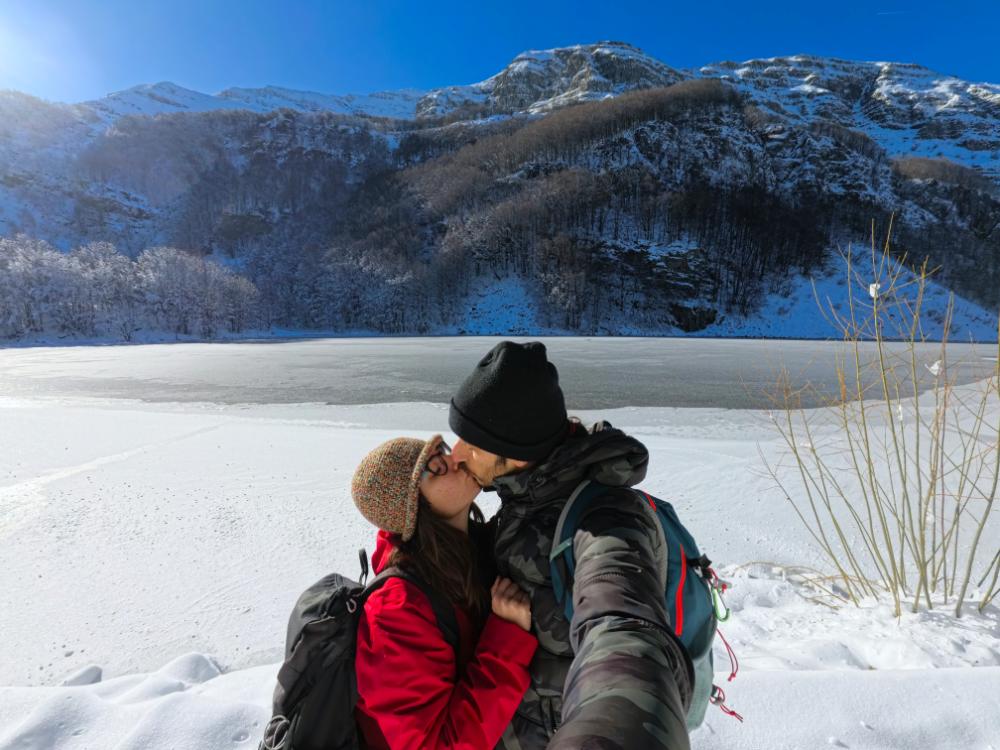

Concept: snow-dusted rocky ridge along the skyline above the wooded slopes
[[11, 42, 1000, 179]]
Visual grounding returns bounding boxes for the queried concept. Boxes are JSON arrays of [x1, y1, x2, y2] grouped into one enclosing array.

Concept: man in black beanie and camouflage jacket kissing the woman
[[449, 341, 692, 750]]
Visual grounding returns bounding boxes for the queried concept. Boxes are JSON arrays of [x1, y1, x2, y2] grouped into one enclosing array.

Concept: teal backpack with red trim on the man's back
[[549, 481, 742, 730]]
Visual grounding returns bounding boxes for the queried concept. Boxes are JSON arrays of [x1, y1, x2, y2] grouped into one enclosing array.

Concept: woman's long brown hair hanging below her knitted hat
[[388, 497, 490, 620]]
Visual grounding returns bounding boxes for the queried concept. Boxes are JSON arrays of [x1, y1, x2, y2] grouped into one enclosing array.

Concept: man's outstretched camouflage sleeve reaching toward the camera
[[548, 497, 691, 750]]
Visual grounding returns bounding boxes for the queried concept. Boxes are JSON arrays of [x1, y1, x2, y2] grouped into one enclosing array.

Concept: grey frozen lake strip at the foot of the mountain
[[0, 337, 997, 409]]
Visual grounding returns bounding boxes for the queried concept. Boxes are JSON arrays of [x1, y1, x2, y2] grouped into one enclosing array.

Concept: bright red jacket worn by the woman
[[355, 531, 538, 750]]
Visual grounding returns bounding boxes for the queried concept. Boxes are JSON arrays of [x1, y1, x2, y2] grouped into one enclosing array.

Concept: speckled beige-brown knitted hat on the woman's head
[[351, 435, 441, 542]]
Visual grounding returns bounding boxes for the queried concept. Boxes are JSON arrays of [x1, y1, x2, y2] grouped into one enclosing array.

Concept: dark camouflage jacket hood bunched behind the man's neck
[[493, 422, 649, 503]]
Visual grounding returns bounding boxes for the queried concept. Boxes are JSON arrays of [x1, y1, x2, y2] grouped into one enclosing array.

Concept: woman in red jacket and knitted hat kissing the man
[[351, 435, 537, 750]]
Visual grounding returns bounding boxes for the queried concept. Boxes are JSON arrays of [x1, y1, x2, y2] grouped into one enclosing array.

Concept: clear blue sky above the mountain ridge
[[0, 0, 1000, 101]]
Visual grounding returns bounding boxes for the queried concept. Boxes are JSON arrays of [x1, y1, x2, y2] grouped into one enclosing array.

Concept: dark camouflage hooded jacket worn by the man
[[491, 422, 691, 750]]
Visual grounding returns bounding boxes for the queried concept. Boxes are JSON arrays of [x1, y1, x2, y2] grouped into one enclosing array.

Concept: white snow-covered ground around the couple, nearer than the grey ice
[[0, 350, 1000, 750]]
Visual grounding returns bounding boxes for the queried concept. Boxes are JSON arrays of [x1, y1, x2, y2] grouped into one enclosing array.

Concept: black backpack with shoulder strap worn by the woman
[[258, 550, 458, 750]]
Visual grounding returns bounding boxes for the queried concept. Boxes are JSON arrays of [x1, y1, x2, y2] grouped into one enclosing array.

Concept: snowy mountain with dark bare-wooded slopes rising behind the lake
[[0, 42, 1000, 340]]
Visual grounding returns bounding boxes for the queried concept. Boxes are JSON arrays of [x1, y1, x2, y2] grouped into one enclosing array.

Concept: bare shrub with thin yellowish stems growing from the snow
[[765, 222, 1000, 616]]
